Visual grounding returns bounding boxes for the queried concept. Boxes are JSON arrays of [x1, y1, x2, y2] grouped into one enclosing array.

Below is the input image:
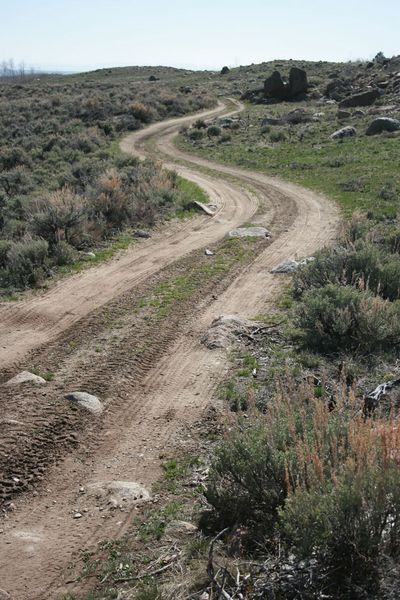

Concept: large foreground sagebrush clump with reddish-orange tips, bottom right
[[203, 381, 400, 598]]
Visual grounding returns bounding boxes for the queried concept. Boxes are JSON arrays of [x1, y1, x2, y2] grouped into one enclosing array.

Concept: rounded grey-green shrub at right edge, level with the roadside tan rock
[[296, 284, 400, 352]]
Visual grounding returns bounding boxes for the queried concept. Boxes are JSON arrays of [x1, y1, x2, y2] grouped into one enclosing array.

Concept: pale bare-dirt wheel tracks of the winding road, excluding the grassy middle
[[0, 101, 337, 600]]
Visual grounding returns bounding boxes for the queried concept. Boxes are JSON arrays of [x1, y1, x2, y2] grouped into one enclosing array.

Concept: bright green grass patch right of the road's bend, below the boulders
[[177, 103, 400, 219]]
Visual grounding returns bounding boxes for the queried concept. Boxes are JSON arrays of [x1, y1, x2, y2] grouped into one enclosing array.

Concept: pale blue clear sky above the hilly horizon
[[0, 0, 400, 71]]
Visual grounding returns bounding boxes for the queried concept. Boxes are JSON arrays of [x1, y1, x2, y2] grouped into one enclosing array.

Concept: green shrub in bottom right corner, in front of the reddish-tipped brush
[[280, 464, 400, 587]]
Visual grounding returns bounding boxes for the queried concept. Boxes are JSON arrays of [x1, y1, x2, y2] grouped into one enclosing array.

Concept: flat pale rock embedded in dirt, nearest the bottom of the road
[[87, 481, 151, 509]]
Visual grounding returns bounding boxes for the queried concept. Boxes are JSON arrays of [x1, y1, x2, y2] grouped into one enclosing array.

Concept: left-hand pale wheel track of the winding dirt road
[[0, 105, 253, 372]]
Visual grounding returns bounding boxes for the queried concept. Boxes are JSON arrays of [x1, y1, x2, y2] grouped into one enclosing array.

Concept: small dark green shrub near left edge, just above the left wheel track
[[8, 240, 48, 289]]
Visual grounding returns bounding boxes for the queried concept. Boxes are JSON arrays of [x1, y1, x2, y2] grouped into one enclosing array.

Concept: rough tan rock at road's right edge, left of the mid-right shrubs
[[201, 315, 261, 350]]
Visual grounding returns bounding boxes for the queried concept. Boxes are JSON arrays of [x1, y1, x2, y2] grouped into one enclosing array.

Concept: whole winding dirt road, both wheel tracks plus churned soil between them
[[0, 103, 338, 600]]
